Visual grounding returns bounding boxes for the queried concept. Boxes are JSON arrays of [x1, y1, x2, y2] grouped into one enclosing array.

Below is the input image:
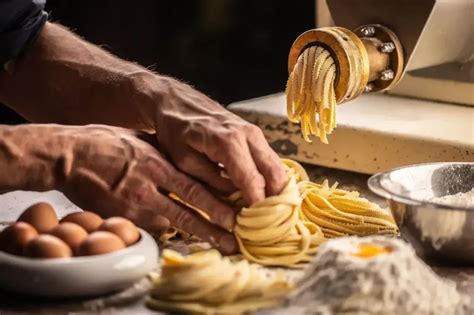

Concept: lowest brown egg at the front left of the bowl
[[24, 234, 72, 258]]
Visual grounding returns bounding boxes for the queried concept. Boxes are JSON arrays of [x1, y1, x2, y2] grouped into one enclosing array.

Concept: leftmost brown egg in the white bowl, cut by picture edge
[[0, 222, 38, 255]]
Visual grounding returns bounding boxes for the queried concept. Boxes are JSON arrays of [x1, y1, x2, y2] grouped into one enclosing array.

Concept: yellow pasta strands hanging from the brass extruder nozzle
[[286, 46, 336, 143]]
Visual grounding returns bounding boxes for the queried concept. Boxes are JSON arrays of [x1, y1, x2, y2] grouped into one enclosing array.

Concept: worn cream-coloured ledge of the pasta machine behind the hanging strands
[[228, 92, 474, 174]]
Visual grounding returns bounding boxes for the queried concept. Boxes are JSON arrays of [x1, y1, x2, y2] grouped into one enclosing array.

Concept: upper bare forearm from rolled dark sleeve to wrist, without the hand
[[0, 23, 161, 129]]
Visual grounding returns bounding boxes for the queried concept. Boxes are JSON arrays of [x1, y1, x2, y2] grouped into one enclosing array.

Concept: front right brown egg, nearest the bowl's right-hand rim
[[79, 231, 126, 256]]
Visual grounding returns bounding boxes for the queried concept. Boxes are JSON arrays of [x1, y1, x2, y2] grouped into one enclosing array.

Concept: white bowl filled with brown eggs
[[0, 203, 158, 297]]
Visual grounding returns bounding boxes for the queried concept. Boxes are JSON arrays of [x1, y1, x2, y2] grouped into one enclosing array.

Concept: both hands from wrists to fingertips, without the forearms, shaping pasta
[[56, 79, 286, 254]]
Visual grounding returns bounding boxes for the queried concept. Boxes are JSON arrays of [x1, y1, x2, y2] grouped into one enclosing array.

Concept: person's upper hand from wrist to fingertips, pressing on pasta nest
[[154, 77, 287, 204]]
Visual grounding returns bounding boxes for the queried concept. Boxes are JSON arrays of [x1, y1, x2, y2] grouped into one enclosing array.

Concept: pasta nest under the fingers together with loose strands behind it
[[158, 159, 398, 267]]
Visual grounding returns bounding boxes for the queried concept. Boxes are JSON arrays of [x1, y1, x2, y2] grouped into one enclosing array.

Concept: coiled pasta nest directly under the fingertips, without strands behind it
[[234, 175, 324, 267]]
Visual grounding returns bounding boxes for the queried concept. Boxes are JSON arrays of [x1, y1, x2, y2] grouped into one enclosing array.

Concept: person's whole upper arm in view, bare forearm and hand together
[[0, 23, 287, 208]]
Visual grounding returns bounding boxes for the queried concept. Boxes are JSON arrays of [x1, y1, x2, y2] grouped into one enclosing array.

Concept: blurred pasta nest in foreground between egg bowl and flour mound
[[147, 250, 292, 314]]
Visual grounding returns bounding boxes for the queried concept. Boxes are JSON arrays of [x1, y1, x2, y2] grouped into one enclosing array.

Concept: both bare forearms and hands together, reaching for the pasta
[[0, 22, 287, 253]]
